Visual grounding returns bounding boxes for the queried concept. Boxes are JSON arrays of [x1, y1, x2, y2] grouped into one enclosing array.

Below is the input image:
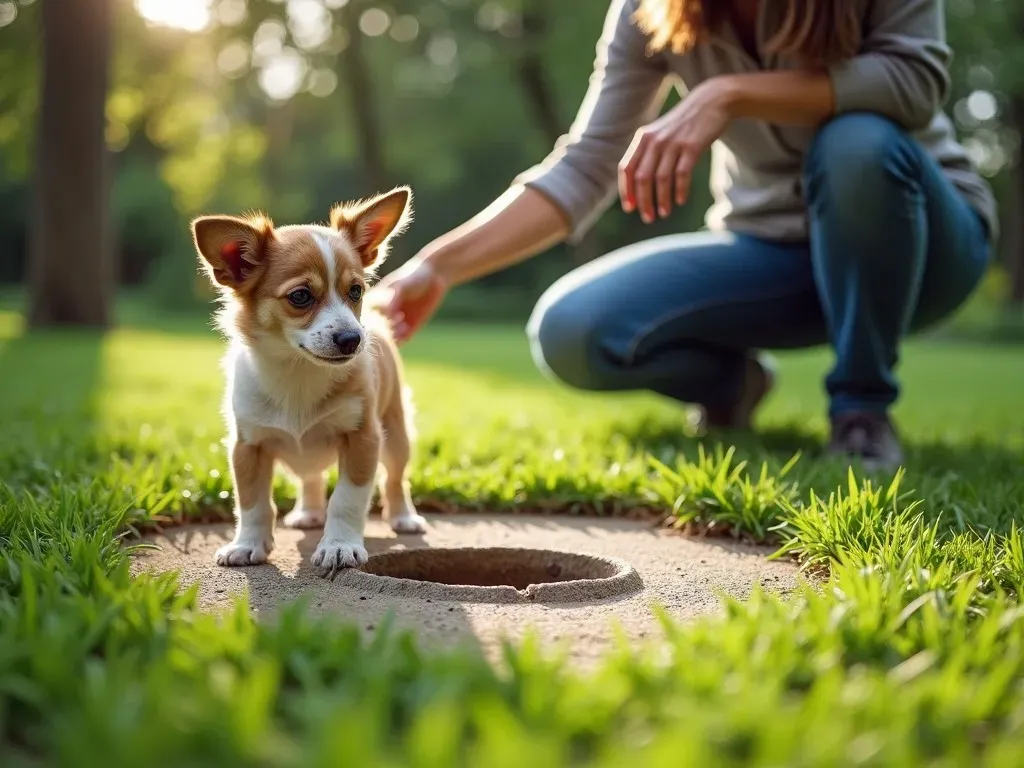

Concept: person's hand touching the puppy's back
[[367, 256, 449, 344]]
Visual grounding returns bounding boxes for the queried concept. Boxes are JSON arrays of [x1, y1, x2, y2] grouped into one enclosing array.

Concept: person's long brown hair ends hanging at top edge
[[636, 0, 861, 67]]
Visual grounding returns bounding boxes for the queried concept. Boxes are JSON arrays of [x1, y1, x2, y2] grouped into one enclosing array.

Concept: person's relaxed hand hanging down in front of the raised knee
[[618, 78, 732, 224]]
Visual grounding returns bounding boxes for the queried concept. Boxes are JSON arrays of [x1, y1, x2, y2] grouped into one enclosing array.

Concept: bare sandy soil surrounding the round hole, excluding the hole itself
[[133, 514, 799, 666]]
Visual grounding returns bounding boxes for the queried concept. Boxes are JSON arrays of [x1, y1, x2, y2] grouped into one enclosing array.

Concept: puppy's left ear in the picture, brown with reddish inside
[[191, 215, 273, 291]]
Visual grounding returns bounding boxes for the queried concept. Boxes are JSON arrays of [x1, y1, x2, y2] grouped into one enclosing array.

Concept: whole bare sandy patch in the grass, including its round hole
[[133, 514, 799, 663]]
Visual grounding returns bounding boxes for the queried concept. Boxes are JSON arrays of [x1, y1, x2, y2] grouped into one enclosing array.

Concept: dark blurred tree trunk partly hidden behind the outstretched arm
[[516, 2, 601, 264]]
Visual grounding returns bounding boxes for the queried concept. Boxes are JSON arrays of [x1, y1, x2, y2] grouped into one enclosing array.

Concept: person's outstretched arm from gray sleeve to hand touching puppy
[[371, 0, 667, 341]]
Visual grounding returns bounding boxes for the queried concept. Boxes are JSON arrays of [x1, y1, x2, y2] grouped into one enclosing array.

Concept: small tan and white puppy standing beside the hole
[[191, 187, 425, 570]]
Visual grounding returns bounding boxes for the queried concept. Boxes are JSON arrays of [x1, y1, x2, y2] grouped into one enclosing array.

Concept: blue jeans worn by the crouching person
[[528, 114, 990, 415]]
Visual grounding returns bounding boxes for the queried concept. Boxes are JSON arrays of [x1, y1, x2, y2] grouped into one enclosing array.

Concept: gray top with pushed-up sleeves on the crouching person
[[516, 0, 998, 243]]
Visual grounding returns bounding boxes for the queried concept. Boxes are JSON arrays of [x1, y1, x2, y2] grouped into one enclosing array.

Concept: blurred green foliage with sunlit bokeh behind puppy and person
[[0, 0, 1024, 313]]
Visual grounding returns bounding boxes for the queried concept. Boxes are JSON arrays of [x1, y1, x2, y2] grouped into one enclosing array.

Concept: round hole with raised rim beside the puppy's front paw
[[336, 547, 643, 603]]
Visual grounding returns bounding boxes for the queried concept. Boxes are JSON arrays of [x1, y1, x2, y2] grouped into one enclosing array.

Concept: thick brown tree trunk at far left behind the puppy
[[29, 0, 114, 328]]
